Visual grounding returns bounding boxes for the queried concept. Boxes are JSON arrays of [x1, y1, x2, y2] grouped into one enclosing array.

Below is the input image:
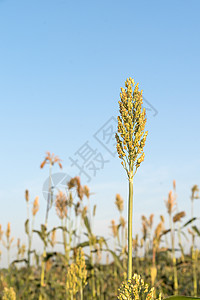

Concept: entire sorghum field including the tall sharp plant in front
[[0, 78, 200, 300]]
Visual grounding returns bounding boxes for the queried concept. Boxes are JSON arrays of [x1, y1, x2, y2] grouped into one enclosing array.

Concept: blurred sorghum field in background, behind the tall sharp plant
[[0, 153, 200, 300]]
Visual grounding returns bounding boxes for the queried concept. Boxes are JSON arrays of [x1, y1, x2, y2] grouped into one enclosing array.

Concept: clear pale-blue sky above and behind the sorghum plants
[[0, 0, 200, 264]]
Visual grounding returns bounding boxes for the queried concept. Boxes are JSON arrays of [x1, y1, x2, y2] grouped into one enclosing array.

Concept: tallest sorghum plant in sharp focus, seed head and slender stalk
[[116, 78, 148, 279]]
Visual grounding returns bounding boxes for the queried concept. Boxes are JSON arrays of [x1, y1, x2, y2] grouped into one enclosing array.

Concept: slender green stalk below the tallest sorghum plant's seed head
[[127, 178, 133, 280]]
